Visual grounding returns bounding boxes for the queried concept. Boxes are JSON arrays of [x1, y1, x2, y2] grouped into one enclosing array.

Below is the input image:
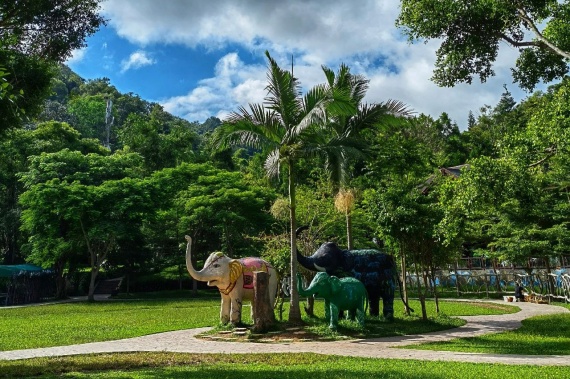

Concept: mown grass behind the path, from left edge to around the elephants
[[0, 292, 517, 351]]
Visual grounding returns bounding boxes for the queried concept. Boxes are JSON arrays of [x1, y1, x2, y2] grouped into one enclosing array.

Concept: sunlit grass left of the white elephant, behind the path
[[0, 298, 220, 350]]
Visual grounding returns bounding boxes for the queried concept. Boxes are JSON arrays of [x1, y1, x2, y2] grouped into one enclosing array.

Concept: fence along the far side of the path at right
[[406, 268, 570, 302]]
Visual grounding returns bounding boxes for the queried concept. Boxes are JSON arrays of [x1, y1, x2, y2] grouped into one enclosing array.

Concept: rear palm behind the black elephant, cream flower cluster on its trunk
[[321, 64, 412, 250]]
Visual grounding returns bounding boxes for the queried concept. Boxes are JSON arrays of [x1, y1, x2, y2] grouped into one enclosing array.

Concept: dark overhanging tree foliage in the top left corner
[[0, 0, 105, 132]]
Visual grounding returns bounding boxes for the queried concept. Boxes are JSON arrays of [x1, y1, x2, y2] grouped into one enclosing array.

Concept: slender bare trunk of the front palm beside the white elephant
[[288, 160, 302, 324]]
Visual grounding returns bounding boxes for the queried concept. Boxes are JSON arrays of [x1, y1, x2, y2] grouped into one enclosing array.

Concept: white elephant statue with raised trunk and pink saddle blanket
[[186, 236, 279, 325]]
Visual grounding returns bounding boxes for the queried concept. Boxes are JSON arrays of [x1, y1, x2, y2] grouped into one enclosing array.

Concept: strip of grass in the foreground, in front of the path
[[0, 353, 570, 379]]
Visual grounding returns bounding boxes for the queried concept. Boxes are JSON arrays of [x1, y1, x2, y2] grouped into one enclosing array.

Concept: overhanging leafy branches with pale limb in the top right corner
[[396, 0, 570, 91]]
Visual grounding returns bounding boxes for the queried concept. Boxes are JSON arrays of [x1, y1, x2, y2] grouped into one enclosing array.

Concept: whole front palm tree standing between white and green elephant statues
[[213, 52, 356, 323]]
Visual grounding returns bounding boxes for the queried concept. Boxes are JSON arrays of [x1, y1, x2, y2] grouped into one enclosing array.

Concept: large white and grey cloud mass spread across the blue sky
[[103, 0, 540, 127]]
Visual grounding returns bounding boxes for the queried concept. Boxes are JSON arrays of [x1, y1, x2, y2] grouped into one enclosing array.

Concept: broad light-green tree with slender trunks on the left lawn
[[20, 150, 148, 300]]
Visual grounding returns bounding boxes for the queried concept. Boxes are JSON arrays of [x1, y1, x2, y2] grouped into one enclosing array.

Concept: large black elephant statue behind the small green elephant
[[297, 232, 414, 320]]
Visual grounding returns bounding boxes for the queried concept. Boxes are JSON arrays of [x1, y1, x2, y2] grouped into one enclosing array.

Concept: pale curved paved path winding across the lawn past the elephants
[[0, 303, 570, 366]]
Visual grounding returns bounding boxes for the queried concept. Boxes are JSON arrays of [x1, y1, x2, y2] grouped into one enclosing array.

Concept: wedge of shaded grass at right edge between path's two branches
[[404, 304, 570, 359]]
